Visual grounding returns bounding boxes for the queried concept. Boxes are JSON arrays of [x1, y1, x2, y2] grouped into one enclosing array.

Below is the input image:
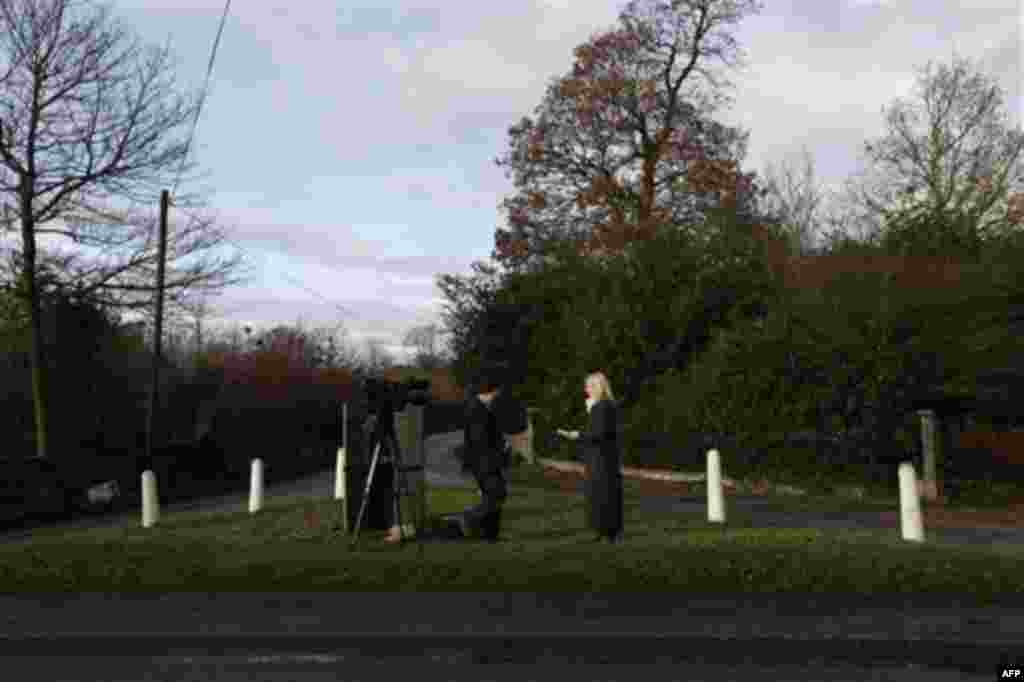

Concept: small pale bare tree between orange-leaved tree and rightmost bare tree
[[764, 146, 825, 255]]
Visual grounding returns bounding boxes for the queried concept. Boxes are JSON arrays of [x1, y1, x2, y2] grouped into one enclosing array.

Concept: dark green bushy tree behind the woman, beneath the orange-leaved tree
[[495, 202, 775, 446]]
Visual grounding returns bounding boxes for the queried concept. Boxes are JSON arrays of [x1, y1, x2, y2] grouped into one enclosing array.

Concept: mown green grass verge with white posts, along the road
[[0, 468, 1024, 603]]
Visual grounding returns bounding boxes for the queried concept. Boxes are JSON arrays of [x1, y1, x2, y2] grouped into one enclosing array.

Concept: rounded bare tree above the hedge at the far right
[[835, 57, 1024, 256]]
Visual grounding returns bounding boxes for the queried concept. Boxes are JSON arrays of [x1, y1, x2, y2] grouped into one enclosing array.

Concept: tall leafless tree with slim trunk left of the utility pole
[[0, 0, 243, 457]]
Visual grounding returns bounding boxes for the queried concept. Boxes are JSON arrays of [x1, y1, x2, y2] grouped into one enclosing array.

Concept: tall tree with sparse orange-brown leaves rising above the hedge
[[493, 0, 760, 267]]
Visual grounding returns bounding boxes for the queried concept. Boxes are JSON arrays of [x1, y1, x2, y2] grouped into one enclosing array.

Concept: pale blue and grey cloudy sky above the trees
[[101, 0, 1024, 360]]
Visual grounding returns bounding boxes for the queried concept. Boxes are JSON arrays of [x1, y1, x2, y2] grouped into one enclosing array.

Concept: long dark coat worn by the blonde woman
[[580, 399, 623, 537]]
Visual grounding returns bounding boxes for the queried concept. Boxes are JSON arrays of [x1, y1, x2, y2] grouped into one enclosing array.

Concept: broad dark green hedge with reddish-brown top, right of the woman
[[667, 220, 1022, 480]]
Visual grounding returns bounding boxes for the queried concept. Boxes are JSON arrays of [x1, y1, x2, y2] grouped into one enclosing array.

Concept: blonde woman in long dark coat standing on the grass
[[558, 372, 623, 544]]
